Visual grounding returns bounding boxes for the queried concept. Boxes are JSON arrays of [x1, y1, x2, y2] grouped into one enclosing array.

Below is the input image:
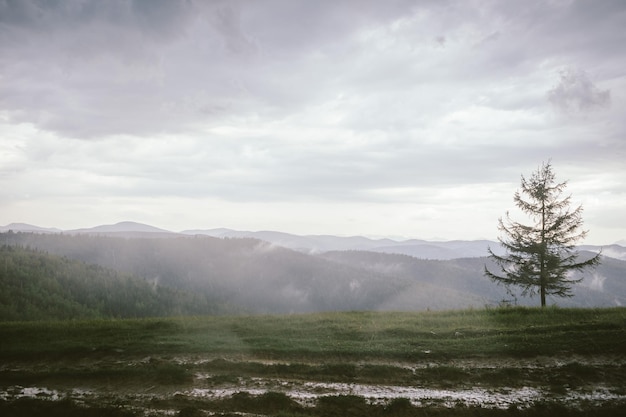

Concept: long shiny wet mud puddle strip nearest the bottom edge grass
[[0, 378, 626, 409]]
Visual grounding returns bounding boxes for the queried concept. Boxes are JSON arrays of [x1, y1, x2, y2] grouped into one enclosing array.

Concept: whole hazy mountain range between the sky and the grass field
[[0, 222, 626, 319]]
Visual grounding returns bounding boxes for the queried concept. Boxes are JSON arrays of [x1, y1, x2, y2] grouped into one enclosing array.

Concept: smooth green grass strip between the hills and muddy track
[[0, 308, 626, 361]]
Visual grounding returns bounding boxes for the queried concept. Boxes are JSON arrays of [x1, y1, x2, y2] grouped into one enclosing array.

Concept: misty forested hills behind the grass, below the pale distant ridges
[[0, 233, 626, 319]]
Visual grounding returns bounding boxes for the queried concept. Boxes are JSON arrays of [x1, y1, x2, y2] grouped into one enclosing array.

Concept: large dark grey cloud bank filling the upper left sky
[[0, 0, 424, 138]]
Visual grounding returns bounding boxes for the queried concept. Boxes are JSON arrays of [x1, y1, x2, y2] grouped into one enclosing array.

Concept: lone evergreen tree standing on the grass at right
[[485, 162, 600, 307]]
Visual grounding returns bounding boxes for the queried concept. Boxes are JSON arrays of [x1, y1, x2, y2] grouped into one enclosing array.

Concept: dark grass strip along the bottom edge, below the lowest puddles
[[0, 392, 624, 417]]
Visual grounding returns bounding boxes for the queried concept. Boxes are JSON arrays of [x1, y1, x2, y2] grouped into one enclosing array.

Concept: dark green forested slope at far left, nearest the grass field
[[0, 245, 216, 320]]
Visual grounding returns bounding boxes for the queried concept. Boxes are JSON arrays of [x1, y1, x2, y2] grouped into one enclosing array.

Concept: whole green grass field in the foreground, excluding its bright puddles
[[0, 308, 626, 416]]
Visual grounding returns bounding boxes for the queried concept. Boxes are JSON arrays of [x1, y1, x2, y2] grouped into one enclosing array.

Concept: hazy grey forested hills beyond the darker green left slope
[[0, 232, 626, 313]]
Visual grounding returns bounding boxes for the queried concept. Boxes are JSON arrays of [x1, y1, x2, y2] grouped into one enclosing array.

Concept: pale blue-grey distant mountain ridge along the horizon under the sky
[[0, 221, 626, 260]]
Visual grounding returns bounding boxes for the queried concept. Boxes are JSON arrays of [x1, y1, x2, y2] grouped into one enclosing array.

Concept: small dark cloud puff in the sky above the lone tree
[[548, 69, 611, 113]]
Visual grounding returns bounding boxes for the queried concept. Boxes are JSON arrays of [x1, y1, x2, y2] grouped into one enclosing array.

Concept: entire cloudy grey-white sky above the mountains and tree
[[0, 0, 626, 244]]
